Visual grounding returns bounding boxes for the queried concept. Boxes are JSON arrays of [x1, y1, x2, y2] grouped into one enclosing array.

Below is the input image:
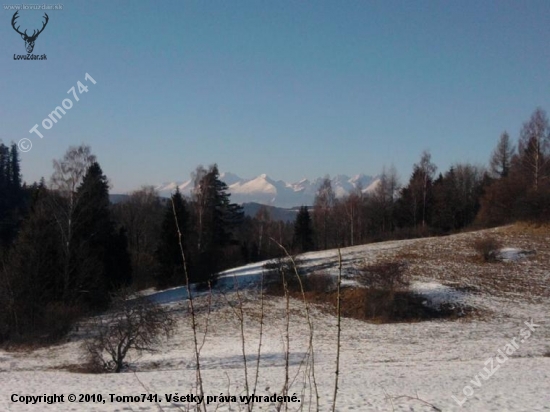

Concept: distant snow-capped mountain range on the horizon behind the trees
[[156, 172, 379, 208]]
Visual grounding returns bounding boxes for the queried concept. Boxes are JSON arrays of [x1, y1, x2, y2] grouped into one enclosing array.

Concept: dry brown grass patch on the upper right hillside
[[394, 223, 550, 303]]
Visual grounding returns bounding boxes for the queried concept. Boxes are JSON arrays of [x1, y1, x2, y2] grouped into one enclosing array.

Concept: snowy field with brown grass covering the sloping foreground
[[0, 227, 550, 412]]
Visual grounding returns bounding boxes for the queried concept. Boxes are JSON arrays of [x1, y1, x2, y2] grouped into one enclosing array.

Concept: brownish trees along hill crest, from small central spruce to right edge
[[294, 108, 550, 251]]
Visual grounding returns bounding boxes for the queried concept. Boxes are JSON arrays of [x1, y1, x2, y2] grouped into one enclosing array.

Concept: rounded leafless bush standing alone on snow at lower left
[[85, 294, 174, 373]]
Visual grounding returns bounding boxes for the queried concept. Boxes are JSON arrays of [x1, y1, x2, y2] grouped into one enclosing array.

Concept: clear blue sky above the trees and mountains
[[0, 0, 550, 192]]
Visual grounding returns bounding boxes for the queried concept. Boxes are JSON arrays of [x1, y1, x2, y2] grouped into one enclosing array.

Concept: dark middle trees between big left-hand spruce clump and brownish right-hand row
[[113, 165, 300, 287]]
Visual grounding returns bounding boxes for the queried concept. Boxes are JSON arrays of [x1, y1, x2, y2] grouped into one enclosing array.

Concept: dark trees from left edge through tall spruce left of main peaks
[[0, 145, 250, 341]]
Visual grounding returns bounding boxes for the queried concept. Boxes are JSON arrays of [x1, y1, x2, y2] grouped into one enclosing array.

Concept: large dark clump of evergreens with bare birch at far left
[[0, 146, 131, 337]]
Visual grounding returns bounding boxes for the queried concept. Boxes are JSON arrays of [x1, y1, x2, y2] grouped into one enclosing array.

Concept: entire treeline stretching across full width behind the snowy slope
[[0, 109, 550, 341]]
